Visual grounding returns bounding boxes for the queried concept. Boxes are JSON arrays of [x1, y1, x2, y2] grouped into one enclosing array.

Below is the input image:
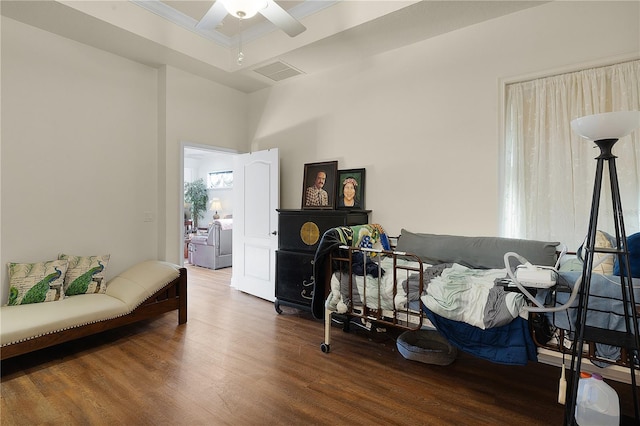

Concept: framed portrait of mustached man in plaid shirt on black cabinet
[[302, 161, 338, 210]]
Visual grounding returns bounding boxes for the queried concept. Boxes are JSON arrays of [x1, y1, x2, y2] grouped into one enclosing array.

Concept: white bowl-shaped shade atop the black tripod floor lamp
[[571, 111, 640, 141]]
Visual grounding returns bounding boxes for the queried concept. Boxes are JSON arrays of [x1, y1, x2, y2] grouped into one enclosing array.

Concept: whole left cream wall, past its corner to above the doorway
[[0, 17, 247, 303]]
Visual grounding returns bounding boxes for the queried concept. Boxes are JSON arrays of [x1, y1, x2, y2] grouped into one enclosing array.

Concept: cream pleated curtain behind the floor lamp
[[502, 61, 640, 250]]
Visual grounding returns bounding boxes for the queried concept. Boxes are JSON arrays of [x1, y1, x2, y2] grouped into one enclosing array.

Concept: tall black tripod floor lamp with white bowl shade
[[565, 111, 640, 425]]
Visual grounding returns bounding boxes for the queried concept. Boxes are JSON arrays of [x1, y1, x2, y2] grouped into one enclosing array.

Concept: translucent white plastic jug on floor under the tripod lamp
[[576, 372, 620, 426]]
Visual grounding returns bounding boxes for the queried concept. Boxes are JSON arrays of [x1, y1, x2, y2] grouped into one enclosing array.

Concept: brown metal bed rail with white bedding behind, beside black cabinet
[[320, 245, 425, 353]]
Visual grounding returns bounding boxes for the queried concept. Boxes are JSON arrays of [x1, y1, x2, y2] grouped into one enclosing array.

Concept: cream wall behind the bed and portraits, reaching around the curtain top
[[250, 2, 640, 240]]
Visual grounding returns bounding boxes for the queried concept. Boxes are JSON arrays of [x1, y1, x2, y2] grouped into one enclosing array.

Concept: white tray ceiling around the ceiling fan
[[0, 0, 546, 93]]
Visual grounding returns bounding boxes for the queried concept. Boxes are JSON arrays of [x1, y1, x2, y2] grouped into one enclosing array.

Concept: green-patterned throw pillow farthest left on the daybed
[[7, 259, 69, 305]]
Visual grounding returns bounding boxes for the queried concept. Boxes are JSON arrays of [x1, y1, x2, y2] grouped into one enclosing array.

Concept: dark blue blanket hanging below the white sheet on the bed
[[422, 304, 538, 365]]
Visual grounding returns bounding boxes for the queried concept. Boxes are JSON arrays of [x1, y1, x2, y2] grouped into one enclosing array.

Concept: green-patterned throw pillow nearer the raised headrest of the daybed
[[58, 254, 110, 296]]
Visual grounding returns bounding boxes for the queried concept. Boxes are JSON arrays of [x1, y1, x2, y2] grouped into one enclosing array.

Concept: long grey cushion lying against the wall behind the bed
[[396, 229, 560, 269]]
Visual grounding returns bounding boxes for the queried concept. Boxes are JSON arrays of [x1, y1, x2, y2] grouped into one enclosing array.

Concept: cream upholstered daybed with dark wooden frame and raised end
[[0, 261, 187, 359]]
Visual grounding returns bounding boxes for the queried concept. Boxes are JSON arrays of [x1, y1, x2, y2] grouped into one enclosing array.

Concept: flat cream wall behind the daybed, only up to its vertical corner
[[0, 17, 158, 303]]
